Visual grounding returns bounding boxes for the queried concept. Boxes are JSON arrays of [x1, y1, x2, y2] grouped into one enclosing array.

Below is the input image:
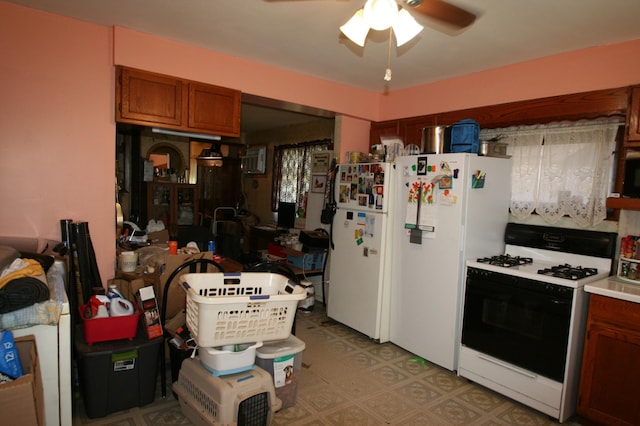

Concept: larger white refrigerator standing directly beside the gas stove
[[390, 154, 511, 371]]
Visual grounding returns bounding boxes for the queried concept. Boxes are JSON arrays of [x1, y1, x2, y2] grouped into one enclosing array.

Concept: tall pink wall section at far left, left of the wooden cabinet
[[0, 3, 115, 281]]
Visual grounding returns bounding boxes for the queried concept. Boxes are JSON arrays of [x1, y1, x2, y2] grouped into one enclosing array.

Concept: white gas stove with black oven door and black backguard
[[458, 223, 617, 422]]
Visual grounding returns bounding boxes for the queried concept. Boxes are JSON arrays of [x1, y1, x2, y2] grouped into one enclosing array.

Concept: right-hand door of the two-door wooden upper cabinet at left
[[189, 82, 240, 137]]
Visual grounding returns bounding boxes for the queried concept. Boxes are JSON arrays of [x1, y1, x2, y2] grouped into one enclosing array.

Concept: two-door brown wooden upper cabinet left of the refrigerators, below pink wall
[[116, 66, 241, 137]]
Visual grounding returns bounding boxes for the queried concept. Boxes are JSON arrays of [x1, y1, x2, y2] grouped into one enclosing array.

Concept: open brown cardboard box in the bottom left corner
[[0, 335, 45, 426]]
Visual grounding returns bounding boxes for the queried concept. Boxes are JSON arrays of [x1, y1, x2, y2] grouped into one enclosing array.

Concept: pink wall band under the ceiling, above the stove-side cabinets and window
[[380, 40, 640, 120]]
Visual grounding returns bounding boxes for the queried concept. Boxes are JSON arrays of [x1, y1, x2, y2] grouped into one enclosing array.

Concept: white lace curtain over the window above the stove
[[480, 121, 620, 227]]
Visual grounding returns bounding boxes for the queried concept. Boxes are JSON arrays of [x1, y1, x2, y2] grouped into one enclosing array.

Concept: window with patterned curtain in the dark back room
[[271, 139, 333, 211]]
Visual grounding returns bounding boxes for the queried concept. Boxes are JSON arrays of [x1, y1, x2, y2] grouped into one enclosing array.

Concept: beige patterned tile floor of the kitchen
[[73, 304, 581, 426]]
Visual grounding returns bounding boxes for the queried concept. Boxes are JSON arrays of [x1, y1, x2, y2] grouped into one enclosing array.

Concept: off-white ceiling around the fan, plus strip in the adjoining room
[[8, 0, 640, 131]]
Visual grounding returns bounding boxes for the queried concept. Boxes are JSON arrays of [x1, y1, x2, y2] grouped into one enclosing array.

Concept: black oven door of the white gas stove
[[462, 268, 573, 382]]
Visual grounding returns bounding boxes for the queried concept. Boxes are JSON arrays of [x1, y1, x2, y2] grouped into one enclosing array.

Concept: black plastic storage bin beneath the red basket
[[75, 325, 164, 418]]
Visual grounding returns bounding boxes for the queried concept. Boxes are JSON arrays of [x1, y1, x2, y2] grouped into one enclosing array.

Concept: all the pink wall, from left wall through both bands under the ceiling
[[0, 0, 640, 281]]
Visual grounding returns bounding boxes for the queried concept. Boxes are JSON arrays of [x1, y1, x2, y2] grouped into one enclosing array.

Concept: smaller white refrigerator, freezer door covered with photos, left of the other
[[327, 163, 393, 343]]
